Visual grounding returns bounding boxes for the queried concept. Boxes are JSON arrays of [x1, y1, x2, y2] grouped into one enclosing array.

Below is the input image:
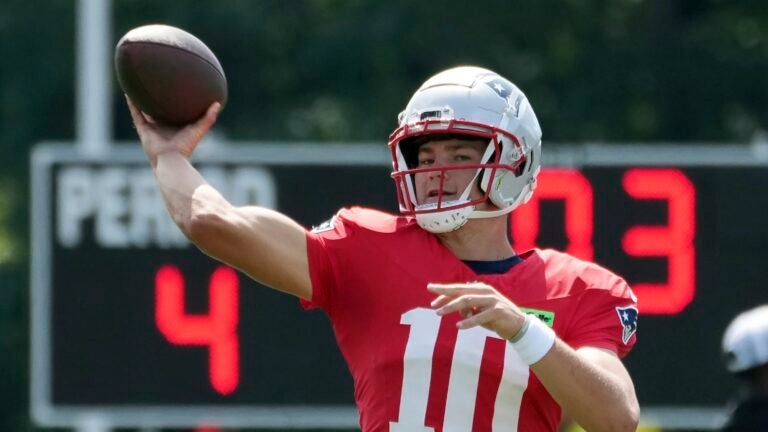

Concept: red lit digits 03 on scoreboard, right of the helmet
[[510, 168, 696, 315]]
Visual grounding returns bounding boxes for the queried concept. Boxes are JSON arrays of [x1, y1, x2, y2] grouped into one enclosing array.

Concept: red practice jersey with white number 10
[[304, 208, 637, 432]]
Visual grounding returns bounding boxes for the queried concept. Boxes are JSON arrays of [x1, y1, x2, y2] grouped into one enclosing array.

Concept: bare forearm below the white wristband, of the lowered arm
[[531, 339, 640, 432]]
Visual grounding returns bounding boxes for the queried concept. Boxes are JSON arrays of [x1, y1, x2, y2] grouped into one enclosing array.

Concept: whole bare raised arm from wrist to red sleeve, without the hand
[[154, 153, 312, 299]]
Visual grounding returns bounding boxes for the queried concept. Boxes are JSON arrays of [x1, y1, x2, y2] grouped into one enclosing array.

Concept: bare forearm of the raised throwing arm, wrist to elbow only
[[153, 152, 228, 235]]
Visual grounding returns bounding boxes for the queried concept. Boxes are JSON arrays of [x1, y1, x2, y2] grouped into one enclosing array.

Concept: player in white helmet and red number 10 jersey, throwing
[[128, 67, 639, 432]]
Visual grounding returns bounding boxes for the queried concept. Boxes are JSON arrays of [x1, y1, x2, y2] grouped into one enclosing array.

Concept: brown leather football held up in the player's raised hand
[[115, 24, 227, 126]]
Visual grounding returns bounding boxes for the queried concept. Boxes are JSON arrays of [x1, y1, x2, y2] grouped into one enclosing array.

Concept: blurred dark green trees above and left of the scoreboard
[[0, 0, 768, 431]]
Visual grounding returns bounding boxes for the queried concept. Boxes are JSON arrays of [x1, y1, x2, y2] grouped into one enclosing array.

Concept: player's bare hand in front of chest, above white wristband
[[427, 282, 525, 339]]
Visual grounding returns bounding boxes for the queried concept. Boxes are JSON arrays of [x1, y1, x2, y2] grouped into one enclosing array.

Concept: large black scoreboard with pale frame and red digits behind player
[[31, 144, 768, 428]]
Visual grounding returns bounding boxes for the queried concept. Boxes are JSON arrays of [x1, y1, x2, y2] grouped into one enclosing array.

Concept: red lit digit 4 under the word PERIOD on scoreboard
[[155, 265, 240, 395]]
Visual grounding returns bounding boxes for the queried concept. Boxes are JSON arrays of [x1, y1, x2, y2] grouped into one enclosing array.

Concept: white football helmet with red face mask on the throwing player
[[389, 66, 541, 233]]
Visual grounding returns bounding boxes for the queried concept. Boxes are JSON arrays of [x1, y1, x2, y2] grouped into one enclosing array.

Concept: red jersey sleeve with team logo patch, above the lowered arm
[[566, 270, 638, 358]]
